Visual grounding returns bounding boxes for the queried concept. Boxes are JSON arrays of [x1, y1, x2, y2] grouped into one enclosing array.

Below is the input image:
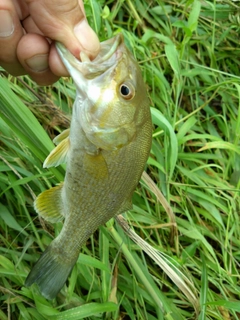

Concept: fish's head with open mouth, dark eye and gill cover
[[57, 35, 149, 150]]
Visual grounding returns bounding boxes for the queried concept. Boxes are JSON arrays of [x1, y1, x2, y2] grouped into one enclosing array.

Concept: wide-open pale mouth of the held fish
[[55, 34, 124, 80]]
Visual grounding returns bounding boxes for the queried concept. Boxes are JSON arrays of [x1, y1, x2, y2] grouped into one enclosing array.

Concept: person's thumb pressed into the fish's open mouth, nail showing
[[25, 0, 100, 58]]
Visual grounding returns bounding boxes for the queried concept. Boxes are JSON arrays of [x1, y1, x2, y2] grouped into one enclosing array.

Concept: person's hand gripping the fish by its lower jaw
[[0, 0, 100, 85]]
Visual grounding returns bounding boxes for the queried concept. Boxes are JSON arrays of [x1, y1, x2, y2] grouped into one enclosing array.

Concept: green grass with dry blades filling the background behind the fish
[[0, 0, 240, 320]]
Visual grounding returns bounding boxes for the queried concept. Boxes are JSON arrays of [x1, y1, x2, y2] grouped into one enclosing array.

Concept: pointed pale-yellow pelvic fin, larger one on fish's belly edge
[[43, 137, 70, 168]]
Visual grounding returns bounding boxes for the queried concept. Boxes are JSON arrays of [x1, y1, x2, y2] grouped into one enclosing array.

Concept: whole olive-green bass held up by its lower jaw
[[25, 34, 152, 300]]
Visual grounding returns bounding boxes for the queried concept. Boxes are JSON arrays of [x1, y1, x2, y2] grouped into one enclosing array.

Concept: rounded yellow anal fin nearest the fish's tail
[[34, 183, 64, 222]]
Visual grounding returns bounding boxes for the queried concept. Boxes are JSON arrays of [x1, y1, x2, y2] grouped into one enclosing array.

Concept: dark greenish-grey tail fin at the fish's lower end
[[25, 245, 76, 300]]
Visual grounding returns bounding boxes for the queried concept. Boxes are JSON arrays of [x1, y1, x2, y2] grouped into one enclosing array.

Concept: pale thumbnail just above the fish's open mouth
[[74, 19, 100, 56]]
